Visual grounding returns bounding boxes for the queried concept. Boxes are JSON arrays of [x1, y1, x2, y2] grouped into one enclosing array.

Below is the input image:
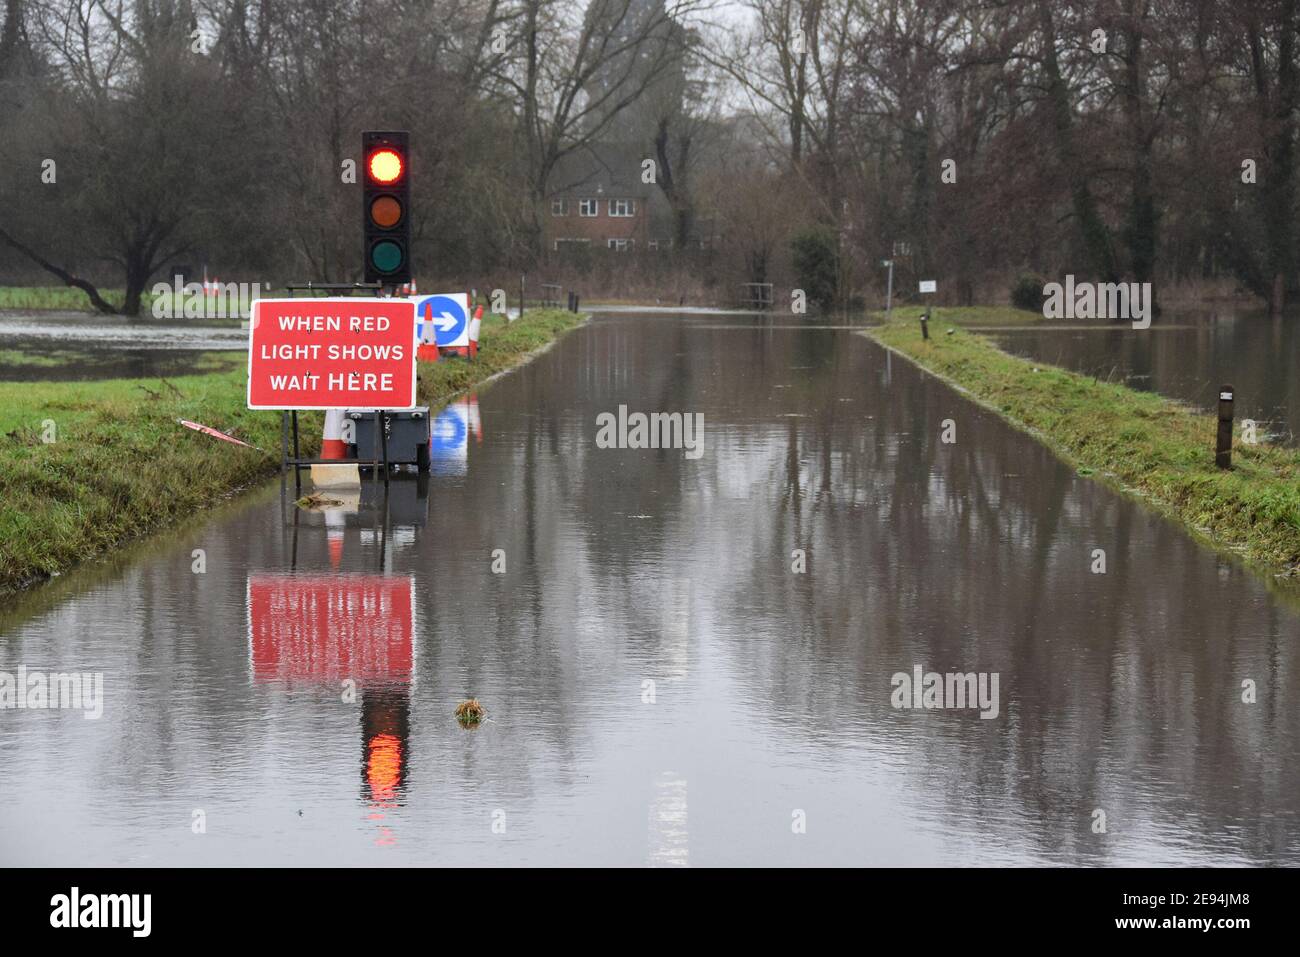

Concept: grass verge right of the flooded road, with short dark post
[[868, 316, 1300, 576]]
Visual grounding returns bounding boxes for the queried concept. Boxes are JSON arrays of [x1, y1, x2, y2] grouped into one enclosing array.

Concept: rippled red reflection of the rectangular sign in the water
[[248, 575, 415, 684]]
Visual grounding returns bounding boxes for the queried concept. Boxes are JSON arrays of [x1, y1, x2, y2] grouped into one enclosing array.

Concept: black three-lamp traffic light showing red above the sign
[[361, 130, 411, 285]]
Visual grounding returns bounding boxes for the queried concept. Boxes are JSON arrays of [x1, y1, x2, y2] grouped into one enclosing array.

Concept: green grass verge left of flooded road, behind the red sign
[[0, 309, 584, 594]]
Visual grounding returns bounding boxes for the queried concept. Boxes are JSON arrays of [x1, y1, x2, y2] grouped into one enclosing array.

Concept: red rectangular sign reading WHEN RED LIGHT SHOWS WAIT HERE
[[248, 299, 416, 408]]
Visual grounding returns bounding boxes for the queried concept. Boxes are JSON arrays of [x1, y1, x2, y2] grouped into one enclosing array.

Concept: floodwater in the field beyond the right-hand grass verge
[[991, 311, 1300, 445]]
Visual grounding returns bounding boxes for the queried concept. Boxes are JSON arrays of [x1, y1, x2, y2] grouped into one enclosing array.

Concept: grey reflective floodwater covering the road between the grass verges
[[0, 315, 1300, 866]]
